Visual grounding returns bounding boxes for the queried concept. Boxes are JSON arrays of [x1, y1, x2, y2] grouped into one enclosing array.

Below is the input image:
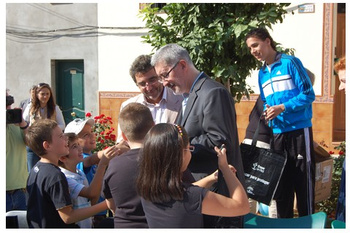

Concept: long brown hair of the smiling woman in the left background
[[30, 83, 56, 118]]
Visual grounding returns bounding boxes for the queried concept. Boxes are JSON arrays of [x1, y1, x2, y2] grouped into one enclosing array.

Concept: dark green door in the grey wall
[[56, 60, 85, 124]]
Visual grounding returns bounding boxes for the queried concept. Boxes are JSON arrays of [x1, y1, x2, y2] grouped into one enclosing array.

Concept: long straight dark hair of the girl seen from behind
[[136, 123, 189, 203]]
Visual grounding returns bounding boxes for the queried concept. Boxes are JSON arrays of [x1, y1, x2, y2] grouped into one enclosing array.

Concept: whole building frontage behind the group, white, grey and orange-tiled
[[6, 1, 346, 146]]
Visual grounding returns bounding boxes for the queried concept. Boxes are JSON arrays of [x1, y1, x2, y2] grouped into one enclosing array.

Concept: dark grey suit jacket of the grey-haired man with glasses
[[177, 73, 244, 195]]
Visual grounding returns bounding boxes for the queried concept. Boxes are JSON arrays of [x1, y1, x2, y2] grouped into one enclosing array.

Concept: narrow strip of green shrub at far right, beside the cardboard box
[[316, 141, 346, 219]]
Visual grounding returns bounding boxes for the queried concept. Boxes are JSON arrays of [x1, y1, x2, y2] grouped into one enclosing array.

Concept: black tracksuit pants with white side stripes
[[274, 127, 315, 218]]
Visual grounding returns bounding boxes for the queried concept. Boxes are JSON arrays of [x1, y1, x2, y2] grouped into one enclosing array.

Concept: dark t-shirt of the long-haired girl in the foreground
[[141, 184, 209, 228]]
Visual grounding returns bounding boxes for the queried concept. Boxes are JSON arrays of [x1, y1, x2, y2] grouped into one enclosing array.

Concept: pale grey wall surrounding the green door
[[3, 3, 99, 112]]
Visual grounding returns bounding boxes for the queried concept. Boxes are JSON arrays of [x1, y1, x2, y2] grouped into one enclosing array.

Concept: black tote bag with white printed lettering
[[240, 119, 287, 205]]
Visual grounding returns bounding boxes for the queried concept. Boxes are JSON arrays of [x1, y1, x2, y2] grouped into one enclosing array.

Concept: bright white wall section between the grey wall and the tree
[[98, 1, 152, 91]]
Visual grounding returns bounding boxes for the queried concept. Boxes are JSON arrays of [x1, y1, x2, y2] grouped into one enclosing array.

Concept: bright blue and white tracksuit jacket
[[259, 53, 315, 134]]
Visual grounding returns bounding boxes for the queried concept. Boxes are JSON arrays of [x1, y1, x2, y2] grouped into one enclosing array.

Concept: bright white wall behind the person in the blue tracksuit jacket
[[247, 3, 323, 95]]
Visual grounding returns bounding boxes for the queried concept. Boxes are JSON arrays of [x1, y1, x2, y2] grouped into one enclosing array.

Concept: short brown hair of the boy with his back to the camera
[[118, 103, 154, 141]]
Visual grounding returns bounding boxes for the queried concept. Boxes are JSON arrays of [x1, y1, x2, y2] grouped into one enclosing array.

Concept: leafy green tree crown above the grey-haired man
[[141, 3, 293, 102]]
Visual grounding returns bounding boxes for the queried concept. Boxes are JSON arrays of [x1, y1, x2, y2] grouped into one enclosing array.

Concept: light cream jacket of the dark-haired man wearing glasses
[[117, 87, 183, 142]]
